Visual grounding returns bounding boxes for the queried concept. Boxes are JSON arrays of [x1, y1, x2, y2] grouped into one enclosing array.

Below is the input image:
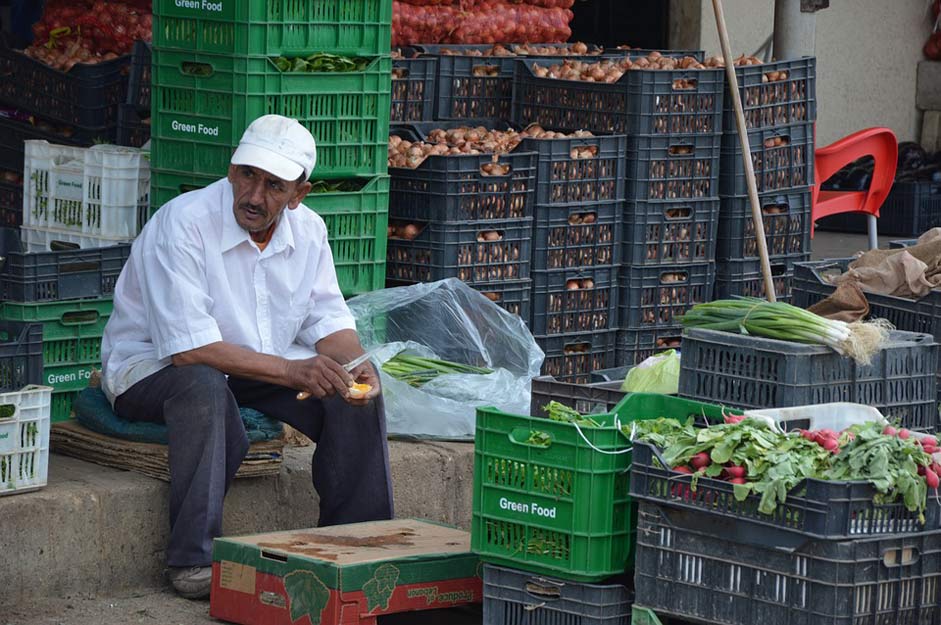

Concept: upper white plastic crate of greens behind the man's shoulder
[[23, 140, 150, 239]]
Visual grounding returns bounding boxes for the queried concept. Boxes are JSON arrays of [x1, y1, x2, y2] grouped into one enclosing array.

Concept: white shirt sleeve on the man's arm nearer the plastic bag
[[297, 231, 356, 348]]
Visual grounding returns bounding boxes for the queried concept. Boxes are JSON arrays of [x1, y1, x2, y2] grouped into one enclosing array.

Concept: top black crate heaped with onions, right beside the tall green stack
[[389, 145, 536, 222]]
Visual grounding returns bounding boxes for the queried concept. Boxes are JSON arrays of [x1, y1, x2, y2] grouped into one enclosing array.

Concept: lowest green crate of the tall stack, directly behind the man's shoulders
[[150, 169, 389, 297]]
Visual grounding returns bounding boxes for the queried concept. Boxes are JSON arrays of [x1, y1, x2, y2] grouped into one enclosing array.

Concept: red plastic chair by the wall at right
[[810, 128, 899, 249]]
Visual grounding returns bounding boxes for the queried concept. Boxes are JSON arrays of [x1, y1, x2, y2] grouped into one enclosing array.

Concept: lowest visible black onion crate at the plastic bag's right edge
[[535, 330, 617, 384]]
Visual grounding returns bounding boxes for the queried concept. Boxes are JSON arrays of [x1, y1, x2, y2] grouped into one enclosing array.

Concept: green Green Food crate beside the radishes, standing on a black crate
[[471, 393, 722, 582]]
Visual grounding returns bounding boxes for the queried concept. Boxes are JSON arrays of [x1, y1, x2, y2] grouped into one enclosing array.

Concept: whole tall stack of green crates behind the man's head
[[151, 0, 392, 296]]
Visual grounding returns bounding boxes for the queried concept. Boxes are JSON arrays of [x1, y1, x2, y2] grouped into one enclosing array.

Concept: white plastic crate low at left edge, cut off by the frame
[[0, 385, 52, 495]]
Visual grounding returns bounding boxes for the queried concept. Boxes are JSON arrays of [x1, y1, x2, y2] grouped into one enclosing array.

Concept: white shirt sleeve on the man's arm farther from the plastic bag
[[139, 234, 222, 359]]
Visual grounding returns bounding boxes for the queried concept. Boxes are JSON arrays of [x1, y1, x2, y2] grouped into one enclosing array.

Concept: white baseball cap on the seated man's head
[[232, 115, 317, 180]]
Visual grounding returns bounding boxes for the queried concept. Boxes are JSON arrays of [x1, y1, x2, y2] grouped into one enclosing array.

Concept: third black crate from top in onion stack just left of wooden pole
[[621, 200, 719, 267]]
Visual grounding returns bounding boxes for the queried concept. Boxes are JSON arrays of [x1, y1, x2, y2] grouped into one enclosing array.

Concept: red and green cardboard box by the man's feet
[[209, 519, 483, 625]]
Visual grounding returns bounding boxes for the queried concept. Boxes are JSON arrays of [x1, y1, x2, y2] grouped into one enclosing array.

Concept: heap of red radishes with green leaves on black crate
[[624, 415, 941, 522]]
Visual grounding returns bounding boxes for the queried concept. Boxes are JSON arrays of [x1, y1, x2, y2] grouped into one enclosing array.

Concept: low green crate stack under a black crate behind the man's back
[[0, 295, 114, 423]]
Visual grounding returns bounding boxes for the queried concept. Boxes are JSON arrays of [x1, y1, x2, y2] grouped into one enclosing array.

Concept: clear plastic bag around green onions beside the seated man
[[348, 279, 543, 440]]
